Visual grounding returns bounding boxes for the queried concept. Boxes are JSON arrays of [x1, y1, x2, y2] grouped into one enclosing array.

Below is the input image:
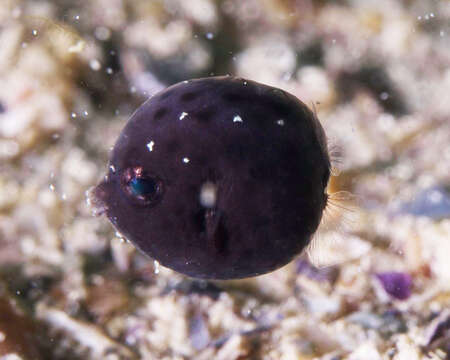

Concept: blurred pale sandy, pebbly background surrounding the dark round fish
[[0, 0, 450, 360]]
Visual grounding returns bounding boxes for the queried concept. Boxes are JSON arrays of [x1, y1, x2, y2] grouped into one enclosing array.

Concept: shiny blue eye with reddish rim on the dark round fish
[[122, 167, 162, 205]]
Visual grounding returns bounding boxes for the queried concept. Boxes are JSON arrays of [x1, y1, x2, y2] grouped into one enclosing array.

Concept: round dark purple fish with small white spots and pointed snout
[[92, 77, 330, 279]]
